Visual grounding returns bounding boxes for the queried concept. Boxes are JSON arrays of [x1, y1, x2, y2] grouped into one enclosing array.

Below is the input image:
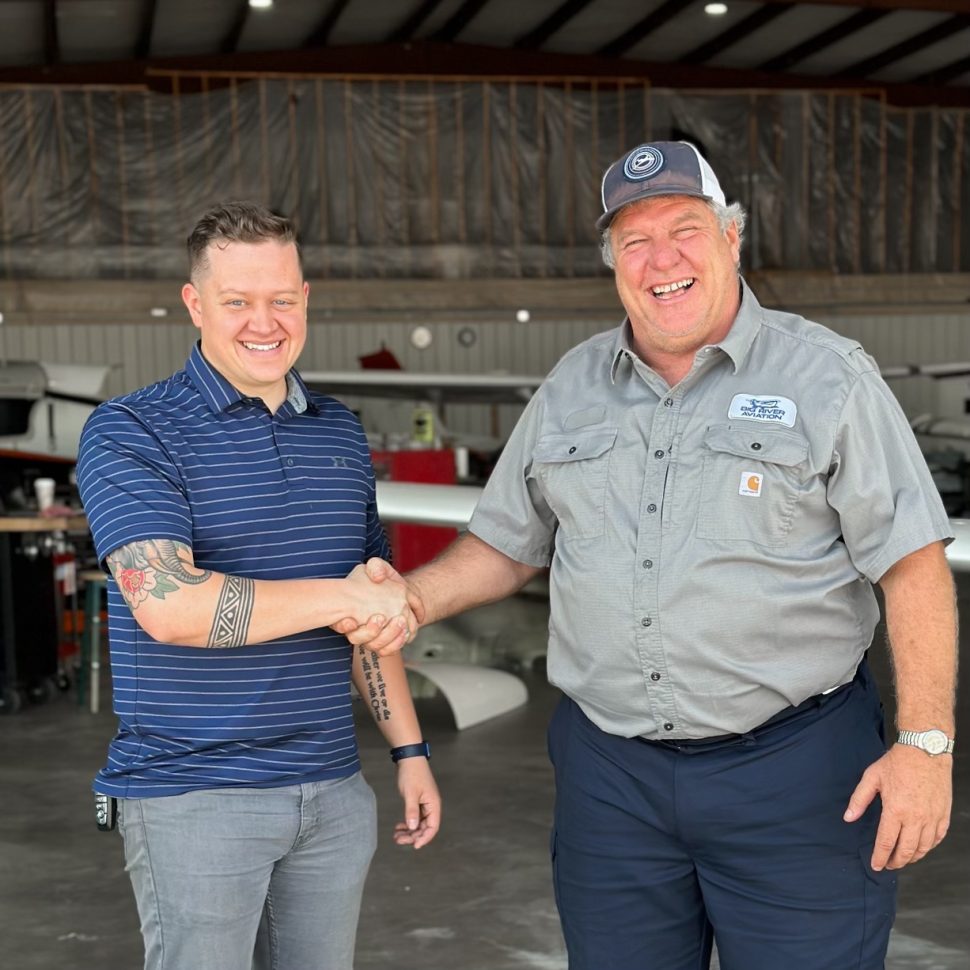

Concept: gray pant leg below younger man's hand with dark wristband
[[253, 772, 377, 970]]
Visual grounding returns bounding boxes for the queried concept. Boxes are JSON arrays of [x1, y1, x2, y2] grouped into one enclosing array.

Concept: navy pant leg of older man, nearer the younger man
[[549, 699, 716, 970]]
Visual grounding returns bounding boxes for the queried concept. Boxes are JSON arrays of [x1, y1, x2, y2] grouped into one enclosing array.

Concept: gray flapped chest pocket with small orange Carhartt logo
[[697, 425, 808, 546]]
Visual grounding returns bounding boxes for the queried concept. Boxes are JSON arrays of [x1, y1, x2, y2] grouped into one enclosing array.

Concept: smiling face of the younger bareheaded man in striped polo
[[182, 239, 310, 412]]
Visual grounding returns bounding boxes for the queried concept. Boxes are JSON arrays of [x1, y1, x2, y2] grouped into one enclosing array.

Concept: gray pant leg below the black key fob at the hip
[[119, 786, 300, 970]]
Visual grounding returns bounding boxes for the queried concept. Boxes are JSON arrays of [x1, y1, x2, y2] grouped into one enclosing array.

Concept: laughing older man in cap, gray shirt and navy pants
[[352, 142, 956, 970]]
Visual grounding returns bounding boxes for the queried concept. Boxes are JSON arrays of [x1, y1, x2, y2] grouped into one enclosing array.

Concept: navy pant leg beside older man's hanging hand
[[680, 673, 896, 970]]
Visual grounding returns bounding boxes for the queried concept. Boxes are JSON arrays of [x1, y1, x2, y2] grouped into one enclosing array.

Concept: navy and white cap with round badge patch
[[596, 141, 727, 232]]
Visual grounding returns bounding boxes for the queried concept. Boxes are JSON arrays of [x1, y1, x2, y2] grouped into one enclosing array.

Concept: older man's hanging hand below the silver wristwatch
[[843, 744, 953, 872]]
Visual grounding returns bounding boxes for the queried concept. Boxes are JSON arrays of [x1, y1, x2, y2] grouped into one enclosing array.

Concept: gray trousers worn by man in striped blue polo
[[118, 773, 377, 970]]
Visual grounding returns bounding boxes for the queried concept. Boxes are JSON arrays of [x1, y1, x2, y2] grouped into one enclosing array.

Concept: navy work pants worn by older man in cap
[[549, 662, 896, 970]]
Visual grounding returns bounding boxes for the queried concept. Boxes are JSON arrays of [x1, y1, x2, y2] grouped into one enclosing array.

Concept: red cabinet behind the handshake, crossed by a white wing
[[371, 448, 458, 573]]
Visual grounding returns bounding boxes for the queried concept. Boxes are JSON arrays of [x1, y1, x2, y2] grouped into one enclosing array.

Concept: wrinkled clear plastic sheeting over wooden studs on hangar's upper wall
[[0, 78, 970, 279]]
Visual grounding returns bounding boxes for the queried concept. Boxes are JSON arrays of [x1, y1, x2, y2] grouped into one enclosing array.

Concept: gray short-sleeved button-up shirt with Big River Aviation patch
[[470, 284, 952, 739]]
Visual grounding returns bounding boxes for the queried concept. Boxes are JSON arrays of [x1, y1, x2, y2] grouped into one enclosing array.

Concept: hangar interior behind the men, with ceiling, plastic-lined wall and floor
[[0, 0, 970, 970]]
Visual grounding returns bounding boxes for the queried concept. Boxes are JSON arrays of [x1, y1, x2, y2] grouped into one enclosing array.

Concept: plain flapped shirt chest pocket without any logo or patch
[[533, 428, 616, 539]]
